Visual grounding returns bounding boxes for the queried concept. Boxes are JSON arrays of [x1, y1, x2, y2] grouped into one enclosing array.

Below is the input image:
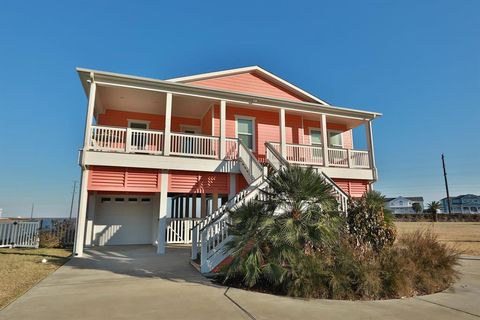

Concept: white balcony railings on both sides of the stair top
[[87, 125, 372, 169]]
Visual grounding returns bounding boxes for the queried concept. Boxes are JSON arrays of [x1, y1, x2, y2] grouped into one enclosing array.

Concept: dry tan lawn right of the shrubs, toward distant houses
[[395, 222, 480, 256]]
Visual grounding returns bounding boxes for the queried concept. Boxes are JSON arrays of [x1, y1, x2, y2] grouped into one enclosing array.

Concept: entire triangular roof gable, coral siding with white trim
[[167, 66, 328, 105]]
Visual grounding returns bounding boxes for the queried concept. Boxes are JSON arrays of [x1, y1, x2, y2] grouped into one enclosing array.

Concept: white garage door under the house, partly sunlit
[[94, 196, 153, 246]]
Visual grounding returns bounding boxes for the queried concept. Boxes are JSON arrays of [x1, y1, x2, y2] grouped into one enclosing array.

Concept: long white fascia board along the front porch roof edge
[[77, 68, 382, 120]]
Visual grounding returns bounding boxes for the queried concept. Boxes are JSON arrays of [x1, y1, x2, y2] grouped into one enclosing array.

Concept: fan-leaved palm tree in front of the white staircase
[[225, 166, 338, 287]]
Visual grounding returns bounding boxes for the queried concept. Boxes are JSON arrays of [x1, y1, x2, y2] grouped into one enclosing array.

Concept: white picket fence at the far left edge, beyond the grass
[[0, 221, 40, 248]]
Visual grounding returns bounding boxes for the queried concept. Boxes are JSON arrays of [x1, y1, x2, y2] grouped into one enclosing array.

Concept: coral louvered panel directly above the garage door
[[87, 167, 160, 192]]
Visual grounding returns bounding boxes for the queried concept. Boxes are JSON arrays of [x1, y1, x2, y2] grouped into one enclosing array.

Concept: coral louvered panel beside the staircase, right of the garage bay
[[168, 171, 230, 194]]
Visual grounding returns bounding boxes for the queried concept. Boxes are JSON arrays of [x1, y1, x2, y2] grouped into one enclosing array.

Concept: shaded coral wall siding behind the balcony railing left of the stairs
[[97, 109, 201, 132]]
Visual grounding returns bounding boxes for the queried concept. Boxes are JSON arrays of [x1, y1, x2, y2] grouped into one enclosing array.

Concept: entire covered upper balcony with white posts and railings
[[80, 71, 378, 180]]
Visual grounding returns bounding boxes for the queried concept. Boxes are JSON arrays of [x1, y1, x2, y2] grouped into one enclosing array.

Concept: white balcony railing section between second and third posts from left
[[170, 132, 220, 159]]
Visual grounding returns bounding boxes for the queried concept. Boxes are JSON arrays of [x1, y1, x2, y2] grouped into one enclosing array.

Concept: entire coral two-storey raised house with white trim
[[75, 66, 381, 270]]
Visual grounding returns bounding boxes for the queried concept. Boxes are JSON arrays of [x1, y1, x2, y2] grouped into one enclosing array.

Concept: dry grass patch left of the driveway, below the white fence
[[0, 248, 72, 310]]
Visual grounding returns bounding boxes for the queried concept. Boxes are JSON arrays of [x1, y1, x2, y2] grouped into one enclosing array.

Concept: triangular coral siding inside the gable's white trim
[[189, 73, 312, 101]]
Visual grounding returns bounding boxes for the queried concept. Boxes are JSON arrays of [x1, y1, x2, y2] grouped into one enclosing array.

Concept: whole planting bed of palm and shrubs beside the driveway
[[219, 167, 458, 299]]
